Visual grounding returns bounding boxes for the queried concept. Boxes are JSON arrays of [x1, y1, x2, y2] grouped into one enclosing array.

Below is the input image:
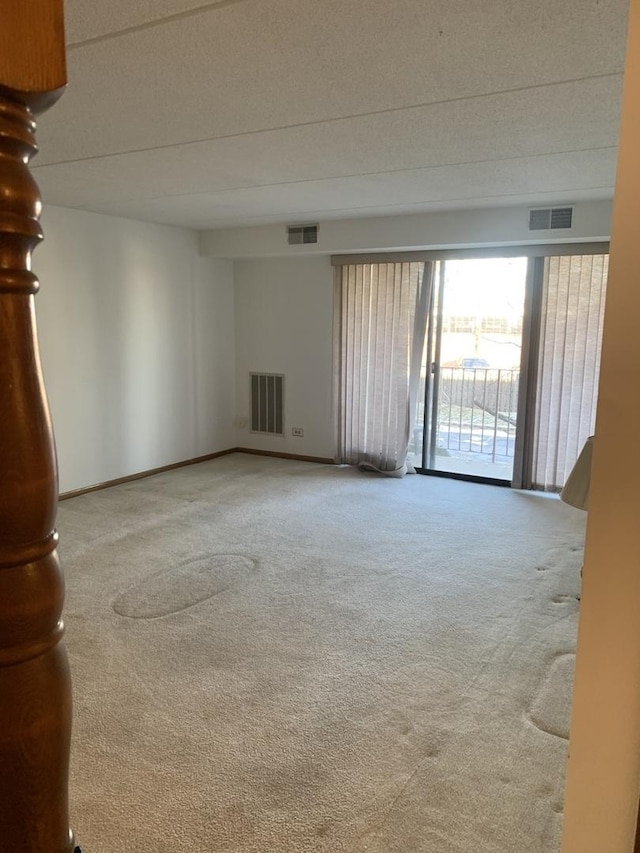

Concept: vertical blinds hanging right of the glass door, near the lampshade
[[533, 255, 609, 491]]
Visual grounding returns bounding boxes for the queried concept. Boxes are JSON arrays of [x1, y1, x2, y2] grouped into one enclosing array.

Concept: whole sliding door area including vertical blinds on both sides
[[336, 244, 608, 491]]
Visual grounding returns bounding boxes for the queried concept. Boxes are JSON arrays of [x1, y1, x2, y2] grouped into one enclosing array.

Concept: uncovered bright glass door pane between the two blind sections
[[422, 258, 527, 482]]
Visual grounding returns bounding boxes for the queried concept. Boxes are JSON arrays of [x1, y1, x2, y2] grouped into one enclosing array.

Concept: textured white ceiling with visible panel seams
[[34, 0, 628, 229]]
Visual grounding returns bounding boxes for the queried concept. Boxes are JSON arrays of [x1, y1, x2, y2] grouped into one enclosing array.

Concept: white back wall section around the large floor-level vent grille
[[234, 257, 335, 458]]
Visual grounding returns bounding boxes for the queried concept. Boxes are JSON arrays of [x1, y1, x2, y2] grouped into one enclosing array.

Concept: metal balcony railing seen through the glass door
[[436, 367, 520, 462]]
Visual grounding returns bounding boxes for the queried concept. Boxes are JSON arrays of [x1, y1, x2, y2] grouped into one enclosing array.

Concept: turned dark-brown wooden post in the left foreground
[[0, 0, 78, 853]]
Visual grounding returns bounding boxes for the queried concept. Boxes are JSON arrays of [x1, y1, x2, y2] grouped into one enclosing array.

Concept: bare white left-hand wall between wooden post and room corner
[[33, 207, 235, 492]]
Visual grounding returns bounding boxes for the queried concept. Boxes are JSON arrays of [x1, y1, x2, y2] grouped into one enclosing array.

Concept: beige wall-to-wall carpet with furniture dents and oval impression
[[59, 454, 584, 853]]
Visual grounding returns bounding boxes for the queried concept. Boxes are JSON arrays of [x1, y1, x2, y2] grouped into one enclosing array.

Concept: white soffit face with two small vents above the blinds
[[200, 200, 611, 258]]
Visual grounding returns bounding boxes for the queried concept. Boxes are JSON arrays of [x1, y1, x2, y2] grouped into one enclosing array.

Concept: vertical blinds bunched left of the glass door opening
[[336, 262, 432, 477]]
